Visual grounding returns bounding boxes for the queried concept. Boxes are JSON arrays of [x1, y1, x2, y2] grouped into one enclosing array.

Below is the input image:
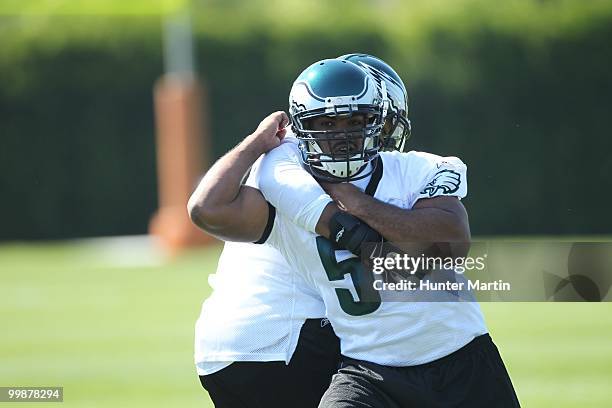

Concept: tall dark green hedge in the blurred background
[[0, 0, 612, 239]]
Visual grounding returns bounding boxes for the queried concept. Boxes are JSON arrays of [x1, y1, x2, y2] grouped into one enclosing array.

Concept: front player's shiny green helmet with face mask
[[289, 59, 387, 182]]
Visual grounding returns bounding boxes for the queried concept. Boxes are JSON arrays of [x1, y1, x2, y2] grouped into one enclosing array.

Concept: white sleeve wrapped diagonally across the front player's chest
[[254, 137, 332, 232]]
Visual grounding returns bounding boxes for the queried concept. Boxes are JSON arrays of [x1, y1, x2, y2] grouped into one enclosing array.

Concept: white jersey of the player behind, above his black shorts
[[195, 242, 325, 375]]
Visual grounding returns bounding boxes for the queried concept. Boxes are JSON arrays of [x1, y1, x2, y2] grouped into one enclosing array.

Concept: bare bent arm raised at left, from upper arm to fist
[[187, 112, 289, 242]]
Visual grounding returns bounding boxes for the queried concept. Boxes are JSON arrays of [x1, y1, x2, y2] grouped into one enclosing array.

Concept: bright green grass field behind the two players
[[0, 241, 612, 408]]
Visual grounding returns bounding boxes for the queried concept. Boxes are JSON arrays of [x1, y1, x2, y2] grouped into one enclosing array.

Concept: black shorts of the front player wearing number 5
[[319, 334, 520, 408]]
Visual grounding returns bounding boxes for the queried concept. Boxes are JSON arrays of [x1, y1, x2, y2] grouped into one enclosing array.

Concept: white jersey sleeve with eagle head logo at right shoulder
[[406, 152, 467, 201]]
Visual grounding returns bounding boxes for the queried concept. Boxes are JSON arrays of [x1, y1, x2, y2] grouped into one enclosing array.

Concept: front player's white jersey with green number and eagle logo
[[257, 143, 487, 366]]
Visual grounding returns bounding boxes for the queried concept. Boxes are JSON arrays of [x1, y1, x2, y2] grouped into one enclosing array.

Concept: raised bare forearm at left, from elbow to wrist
[[188, 135, 265, 231]]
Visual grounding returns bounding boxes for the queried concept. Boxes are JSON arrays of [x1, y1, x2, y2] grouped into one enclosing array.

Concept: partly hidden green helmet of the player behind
[[338, 54, 411, 152]]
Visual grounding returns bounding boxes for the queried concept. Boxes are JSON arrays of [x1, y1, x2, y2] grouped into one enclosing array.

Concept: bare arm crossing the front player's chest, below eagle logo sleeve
[[324, 183, 471, 255]]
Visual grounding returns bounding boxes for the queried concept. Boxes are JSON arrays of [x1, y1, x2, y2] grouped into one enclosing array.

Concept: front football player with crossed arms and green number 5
[[190, 59, 518, 407]]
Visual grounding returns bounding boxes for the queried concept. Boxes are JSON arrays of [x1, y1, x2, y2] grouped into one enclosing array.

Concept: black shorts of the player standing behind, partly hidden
[[200, 319, 340, 408]]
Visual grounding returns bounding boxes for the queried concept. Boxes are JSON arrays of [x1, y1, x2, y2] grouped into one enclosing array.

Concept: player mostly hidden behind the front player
[[194, 54, 409, 407]]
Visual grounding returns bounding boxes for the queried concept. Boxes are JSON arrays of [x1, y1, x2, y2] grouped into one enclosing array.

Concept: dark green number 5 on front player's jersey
[[317, 236, 380, 316]]
